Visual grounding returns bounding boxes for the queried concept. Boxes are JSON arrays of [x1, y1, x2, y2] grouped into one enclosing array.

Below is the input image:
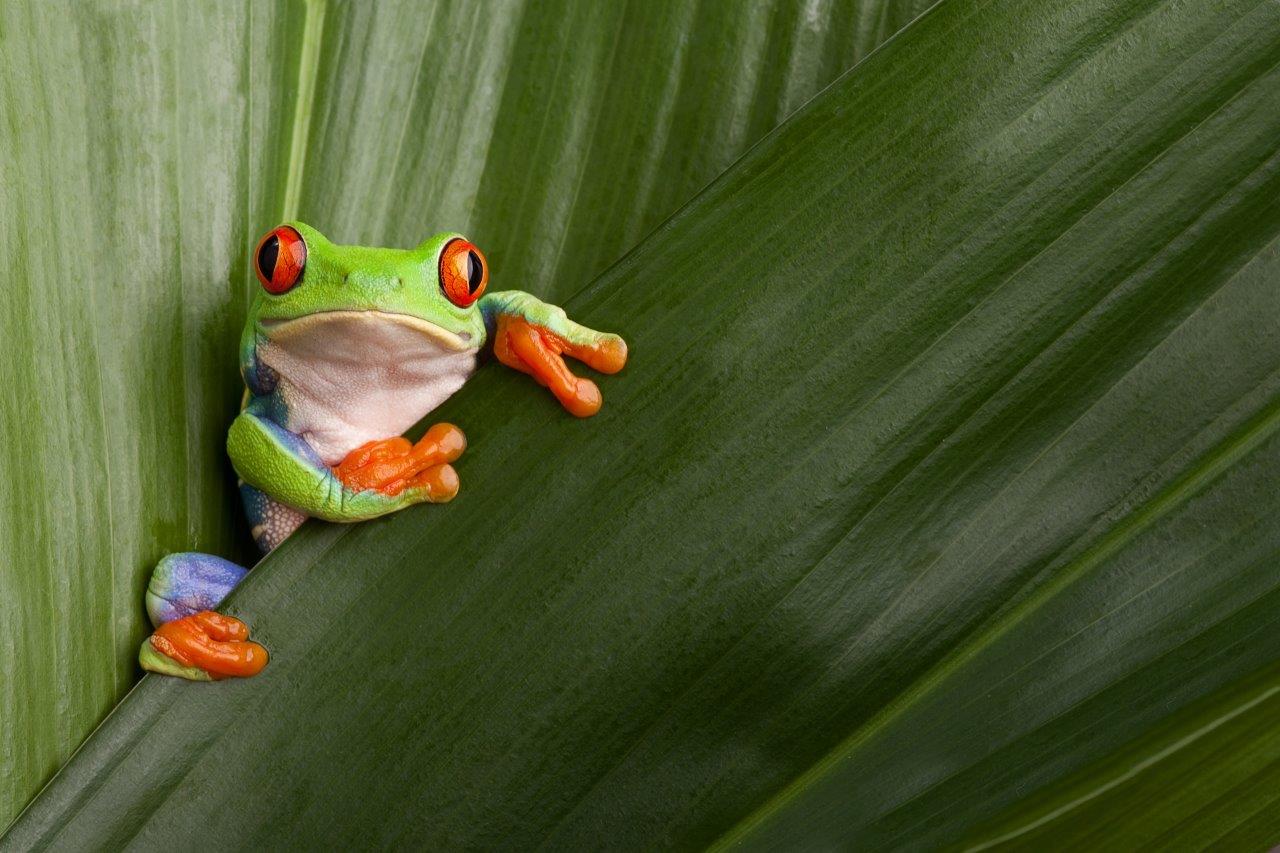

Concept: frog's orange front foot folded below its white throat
[[333, 424, 467, 503]]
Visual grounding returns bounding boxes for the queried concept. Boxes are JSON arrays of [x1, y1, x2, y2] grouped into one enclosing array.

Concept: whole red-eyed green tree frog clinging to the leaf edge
[[138, 222, 627, 681]]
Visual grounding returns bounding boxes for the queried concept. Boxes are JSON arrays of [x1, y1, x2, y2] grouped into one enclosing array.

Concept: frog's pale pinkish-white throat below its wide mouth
[[257, 311, 479, 465]]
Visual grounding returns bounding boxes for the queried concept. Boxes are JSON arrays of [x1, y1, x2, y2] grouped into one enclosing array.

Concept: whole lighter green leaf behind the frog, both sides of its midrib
[[0, 0, 925, 825]]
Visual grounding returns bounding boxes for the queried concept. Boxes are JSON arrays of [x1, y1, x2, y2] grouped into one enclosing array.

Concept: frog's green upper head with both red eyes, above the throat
[[250, 222, 489, 352]]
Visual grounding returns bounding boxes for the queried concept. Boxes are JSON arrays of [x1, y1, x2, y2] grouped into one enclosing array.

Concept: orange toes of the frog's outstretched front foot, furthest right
[[493, 314, 627, 418]]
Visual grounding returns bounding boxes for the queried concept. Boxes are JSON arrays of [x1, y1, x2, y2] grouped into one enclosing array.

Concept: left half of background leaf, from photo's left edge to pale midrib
[[0, 3, 298, 822]]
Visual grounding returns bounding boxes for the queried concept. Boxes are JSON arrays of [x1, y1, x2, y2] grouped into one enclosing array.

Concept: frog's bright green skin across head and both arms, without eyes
[[227, 222, 613, 521]]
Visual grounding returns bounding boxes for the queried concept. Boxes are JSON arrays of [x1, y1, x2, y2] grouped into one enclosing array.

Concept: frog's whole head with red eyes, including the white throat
[[241, 222, 489, 435]]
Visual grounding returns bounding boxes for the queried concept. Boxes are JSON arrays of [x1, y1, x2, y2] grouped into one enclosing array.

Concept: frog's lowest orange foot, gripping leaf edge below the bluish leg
[[138, 610, 269, 681]]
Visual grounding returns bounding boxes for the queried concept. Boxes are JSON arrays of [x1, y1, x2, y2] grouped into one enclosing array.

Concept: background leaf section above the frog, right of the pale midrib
[[300, 0, 932, 300]]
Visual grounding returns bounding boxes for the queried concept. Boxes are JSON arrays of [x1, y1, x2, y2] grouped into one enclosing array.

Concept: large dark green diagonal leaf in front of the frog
[[9, 0, 1280, 849]]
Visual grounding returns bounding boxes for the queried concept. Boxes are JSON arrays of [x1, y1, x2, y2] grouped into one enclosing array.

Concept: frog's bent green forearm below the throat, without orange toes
[[227, 410, 416, 521]]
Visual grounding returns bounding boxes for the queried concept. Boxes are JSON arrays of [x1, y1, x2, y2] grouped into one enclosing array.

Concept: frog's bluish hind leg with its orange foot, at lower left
[[138, 553, 268, 681]]
